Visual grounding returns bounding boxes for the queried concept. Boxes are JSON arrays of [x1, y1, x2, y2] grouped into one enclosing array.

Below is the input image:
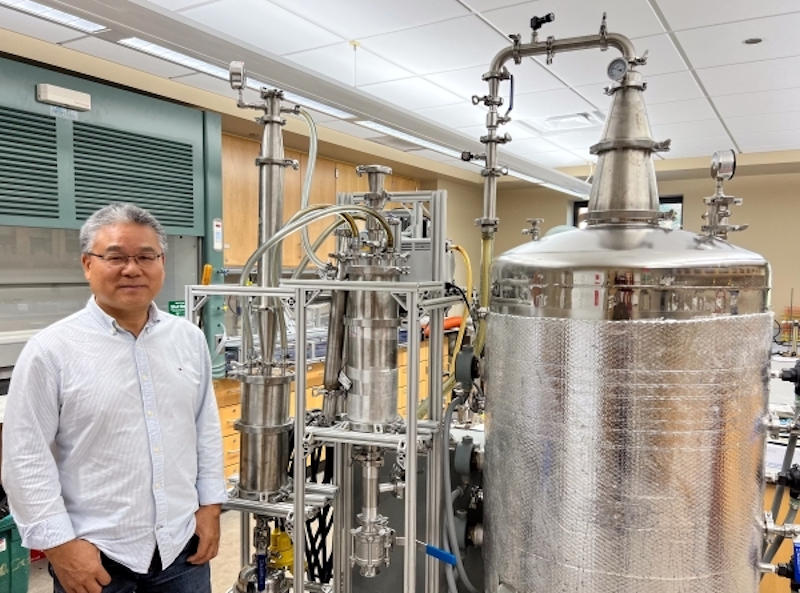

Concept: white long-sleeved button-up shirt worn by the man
[[2, 297, 226, 573]]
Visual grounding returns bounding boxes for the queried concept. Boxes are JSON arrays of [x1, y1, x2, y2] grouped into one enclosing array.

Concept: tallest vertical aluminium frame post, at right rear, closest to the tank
[[425, 191, 447, 593]]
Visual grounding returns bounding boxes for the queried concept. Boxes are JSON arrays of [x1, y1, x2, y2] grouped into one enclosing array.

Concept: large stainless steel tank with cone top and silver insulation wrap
[[485, 60, 772, 593]]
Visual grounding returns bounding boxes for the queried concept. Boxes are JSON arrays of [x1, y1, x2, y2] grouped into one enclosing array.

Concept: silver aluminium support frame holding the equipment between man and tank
[[185, 278, 454, 593]]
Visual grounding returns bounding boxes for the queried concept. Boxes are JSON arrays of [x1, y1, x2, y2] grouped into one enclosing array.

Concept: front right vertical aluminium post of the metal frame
[[403, 290, 419, 593]]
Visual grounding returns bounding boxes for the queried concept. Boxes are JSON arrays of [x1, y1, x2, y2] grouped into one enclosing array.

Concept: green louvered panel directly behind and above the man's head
[[73, 122, 195, 227]]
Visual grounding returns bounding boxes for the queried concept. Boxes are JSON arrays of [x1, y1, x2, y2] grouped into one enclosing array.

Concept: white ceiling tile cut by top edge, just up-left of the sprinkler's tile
[[181, 0, 343, 55]]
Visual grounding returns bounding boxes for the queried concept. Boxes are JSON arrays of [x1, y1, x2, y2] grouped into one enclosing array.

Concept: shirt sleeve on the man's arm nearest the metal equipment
[[195, 332, 228, 505]]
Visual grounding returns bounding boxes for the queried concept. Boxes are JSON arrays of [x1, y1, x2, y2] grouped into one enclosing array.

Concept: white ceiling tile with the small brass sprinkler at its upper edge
[[286, 41, 412, 86]]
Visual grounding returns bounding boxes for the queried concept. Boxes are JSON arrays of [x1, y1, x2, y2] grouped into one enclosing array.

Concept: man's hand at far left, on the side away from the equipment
[[44, 539, 111, 593]]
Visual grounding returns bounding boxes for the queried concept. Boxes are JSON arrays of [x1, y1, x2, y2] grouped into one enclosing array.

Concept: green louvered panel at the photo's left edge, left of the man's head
[[0, 107, 59, 219]]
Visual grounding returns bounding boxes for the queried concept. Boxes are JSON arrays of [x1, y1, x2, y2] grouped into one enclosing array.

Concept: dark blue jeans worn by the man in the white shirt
[[50, 535, 211, 593]]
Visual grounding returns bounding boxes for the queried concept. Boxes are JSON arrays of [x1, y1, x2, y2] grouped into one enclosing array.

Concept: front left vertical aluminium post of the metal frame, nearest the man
[[294, 288, 306, 592]]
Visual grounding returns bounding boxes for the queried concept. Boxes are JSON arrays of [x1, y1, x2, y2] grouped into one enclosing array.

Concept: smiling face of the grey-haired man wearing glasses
[[81, 223, 164, 316]]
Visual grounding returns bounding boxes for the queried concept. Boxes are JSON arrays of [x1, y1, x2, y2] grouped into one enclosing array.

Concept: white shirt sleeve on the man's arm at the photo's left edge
[[2, 338, 75, 550]]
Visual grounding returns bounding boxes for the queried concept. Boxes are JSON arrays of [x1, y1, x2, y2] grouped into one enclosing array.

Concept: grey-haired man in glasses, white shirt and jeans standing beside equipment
[[2, 204, 226, 593]]
